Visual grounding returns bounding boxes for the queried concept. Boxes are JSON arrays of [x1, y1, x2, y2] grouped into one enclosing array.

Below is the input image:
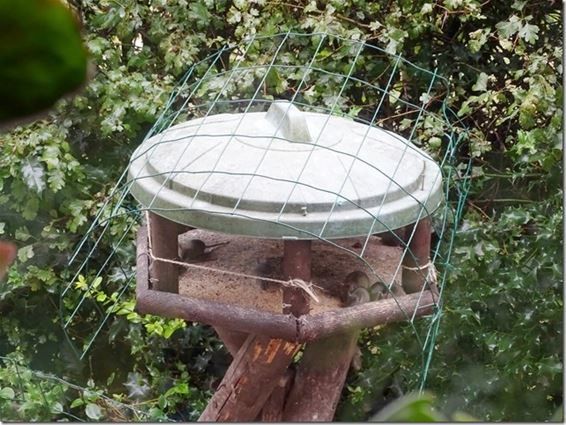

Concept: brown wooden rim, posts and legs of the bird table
[[137, 213, 436, 421]]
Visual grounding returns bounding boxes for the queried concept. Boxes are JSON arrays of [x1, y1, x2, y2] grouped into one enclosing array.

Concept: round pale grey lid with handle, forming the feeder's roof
[[129, 101, 443, 239]]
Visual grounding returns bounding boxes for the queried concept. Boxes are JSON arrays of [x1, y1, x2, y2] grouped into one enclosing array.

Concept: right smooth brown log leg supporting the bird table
[[283, 330, 359, 422]]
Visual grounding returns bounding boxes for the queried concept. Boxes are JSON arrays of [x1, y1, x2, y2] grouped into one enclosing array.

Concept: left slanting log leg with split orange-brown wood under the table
[[199, 335, 300, 422]]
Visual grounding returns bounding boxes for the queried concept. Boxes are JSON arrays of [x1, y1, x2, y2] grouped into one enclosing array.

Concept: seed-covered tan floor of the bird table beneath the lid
[[179, 229, 402, 314]]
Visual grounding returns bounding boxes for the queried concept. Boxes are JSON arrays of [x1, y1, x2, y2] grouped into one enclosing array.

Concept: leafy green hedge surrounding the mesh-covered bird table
[[0, 0, 563, 421]]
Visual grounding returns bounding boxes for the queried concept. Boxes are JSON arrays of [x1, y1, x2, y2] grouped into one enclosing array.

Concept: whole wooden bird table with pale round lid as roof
[[128, 101, 443, 421]]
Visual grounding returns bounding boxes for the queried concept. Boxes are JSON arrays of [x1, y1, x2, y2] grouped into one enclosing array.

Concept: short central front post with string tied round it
[[283, 240, 312, 317]]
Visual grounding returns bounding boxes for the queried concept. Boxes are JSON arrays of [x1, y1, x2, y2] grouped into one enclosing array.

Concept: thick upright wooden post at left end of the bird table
[[149, 212, 179, 293]]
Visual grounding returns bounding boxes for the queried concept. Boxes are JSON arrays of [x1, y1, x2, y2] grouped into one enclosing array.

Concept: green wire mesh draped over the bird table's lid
[[60, 31, 470, 394]]
